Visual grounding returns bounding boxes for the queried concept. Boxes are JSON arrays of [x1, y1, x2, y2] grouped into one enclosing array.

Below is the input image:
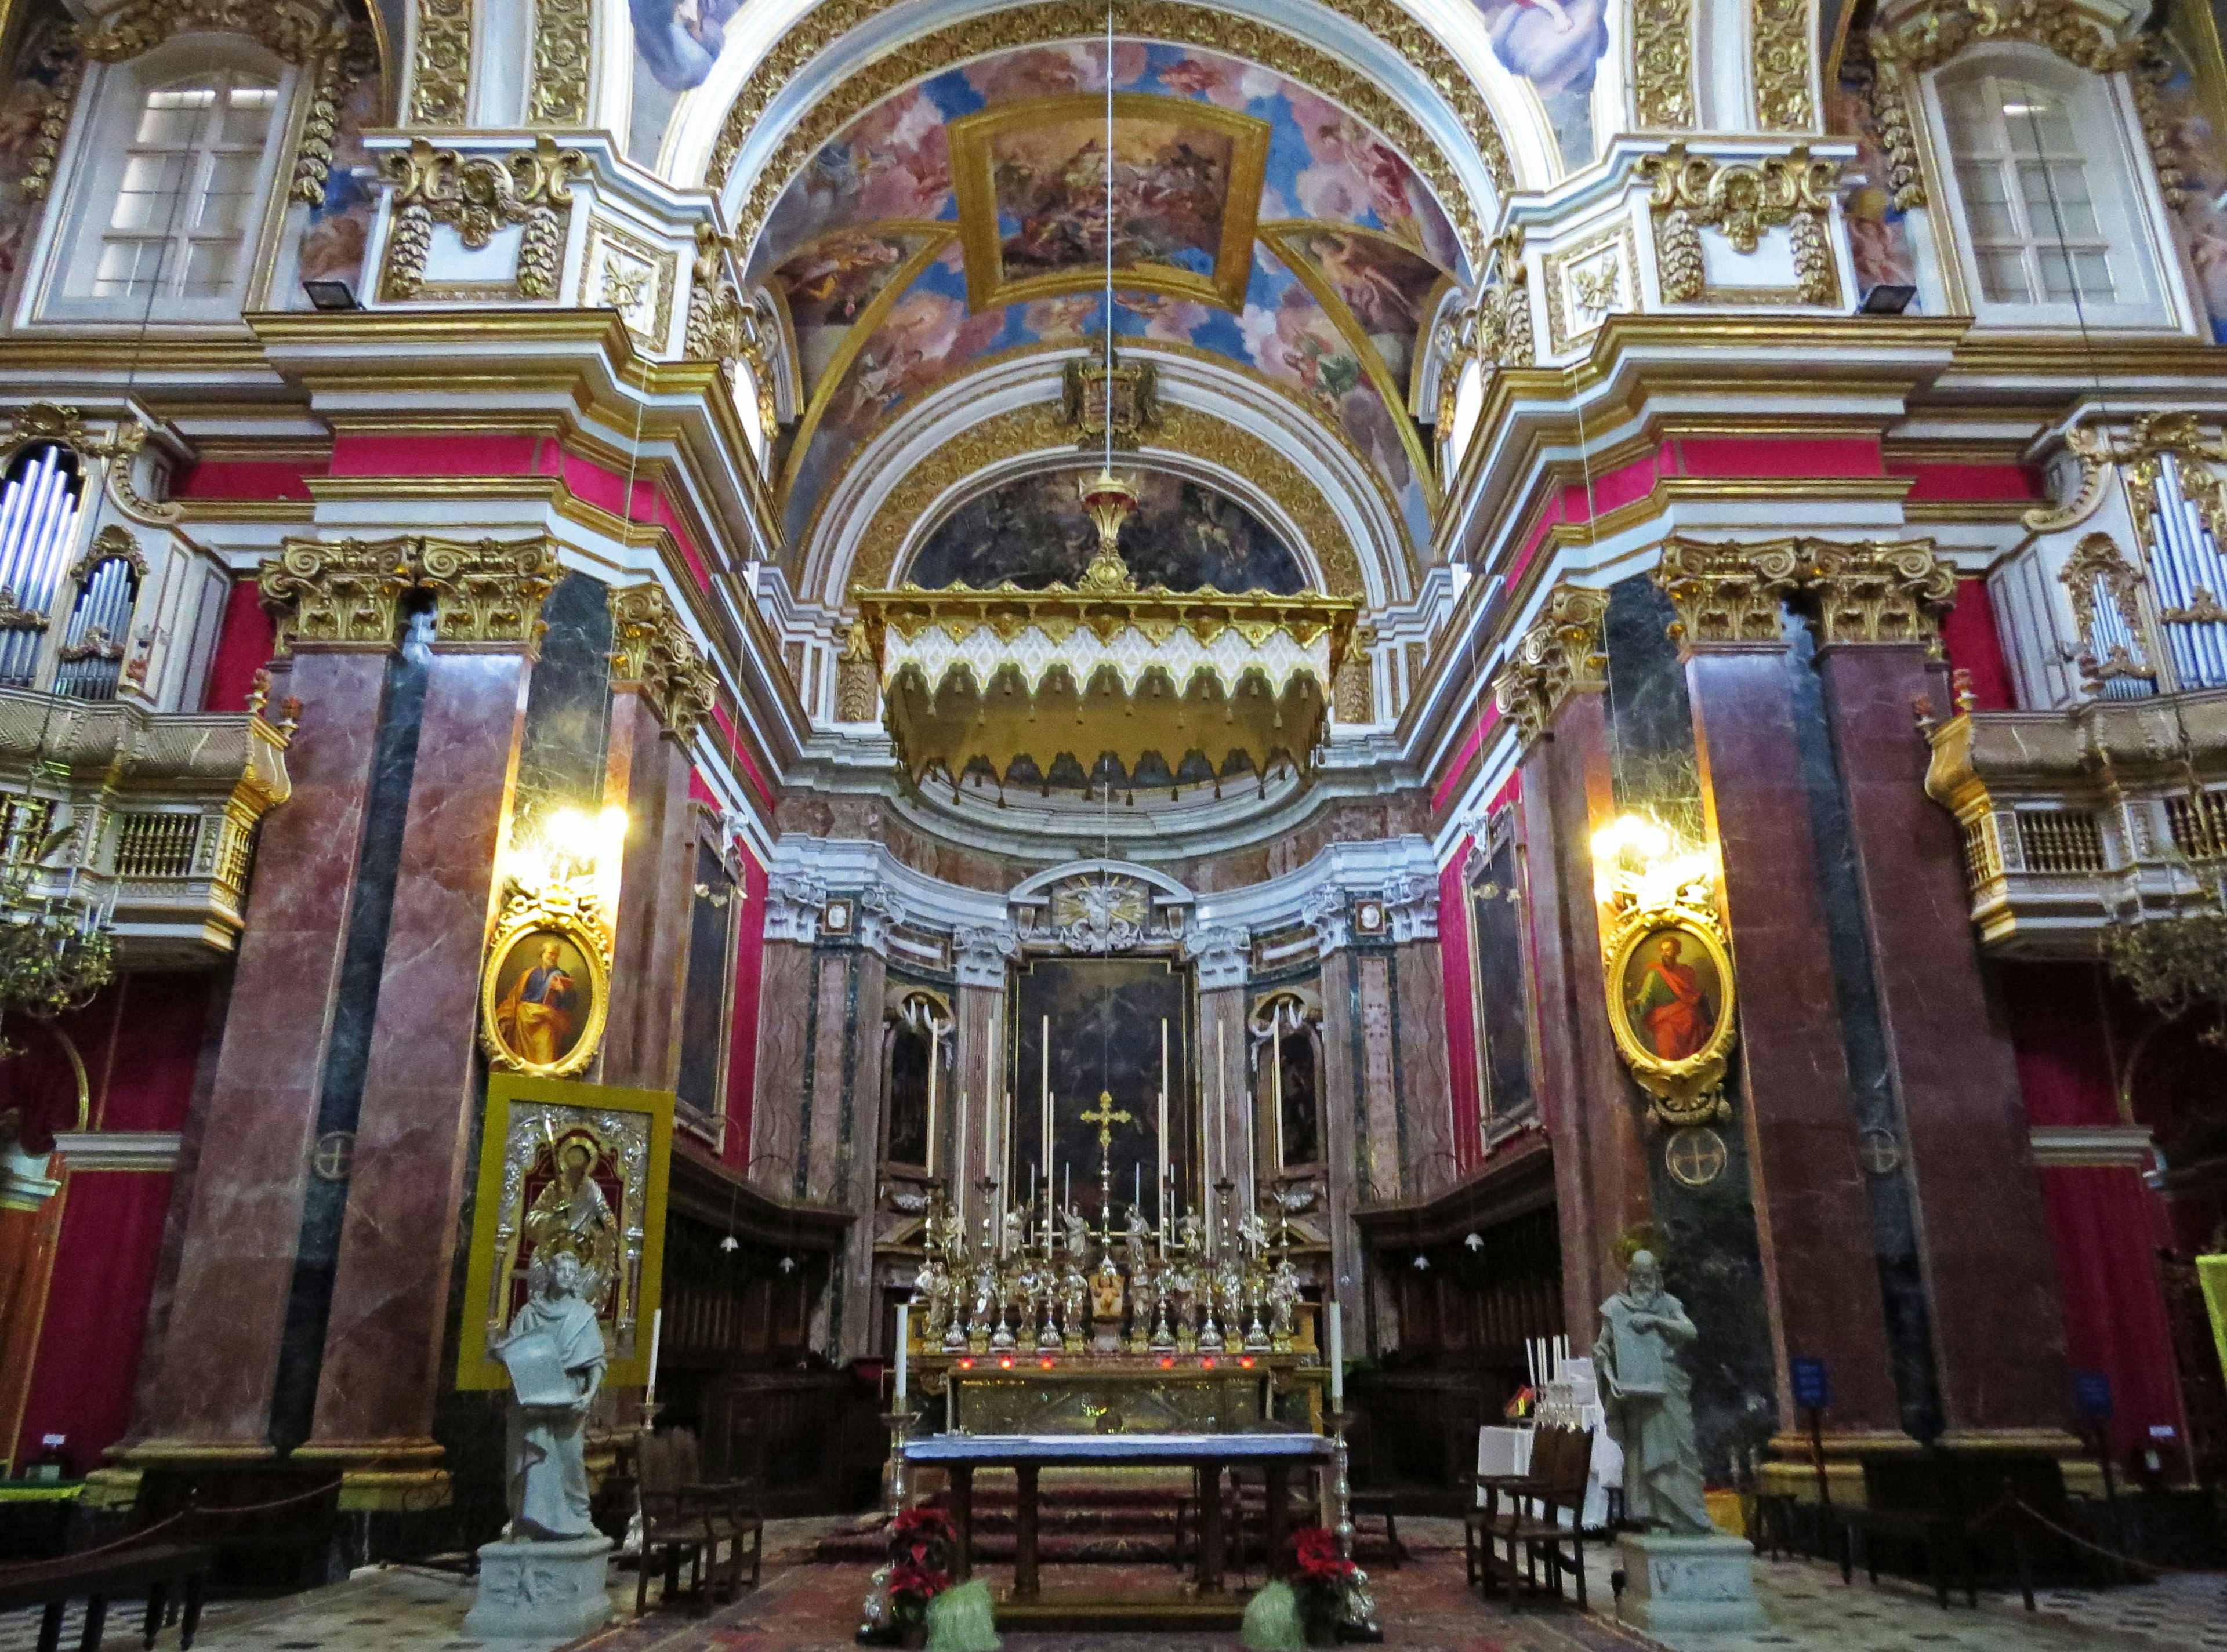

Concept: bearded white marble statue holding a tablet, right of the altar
[[1593, 1251, 1717, 1536]]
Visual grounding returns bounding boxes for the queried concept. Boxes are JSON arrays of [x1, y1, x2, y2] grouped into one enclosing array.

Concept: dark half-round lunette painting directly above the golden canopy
[[904, 465, 1310, 597]]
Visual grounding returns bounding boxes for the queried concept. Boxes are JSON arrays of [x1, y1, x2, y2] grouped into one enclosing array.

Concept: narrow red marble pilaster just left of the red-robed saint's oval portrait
[[1519, 692, 1652, 1325]]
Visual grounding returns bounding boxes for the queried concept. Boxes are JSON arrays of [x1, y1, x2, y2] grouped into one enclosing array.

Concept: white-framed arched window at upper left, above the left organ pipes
[[40, 35, 296, 321]]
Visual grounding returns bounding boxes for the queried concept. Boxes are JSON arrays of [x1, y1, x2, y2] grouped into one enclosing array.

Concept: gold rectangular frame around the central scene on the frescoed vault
[[946, 91, 1272, 312]]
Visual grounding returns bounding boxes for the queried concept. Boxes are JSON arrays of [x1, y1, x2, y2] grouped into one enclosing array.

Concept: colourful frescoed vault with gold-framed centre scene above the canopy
[[753, 42, 1468, 574]]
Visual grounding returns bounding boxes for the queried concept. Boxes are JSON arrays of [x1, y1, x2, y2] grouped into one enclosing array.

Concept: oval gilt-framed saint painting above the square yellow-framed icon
[[479, 884, 610, 1077]]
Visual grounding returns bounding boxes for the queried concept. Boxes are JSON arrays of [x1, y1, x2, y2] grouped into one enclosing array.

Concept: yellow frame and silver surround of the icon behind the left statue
[[456, 1073, 673, 1389]]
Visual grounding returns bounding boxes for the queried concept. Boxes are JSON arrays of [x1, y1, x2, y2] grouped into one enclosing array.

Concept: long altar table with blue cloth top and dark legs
[[904, 1434, 1332, 1601]]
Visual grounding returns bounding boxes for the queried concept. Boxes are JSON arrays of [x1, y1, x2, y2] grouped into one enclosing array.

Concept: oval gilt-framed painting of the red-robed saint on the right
[[1604, 906, 1737, 1124]]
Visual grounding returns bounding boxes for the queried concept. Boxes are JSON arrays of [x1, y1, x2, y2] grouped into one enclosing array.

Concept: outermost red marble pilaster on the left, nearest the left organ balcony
[[132, 644, 390, 1458]]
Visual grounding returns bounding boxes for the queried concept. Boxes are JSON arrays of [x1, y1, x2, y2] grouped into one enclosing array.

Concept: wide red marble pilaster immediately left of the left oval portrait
[[298, 644, 528, 1496]]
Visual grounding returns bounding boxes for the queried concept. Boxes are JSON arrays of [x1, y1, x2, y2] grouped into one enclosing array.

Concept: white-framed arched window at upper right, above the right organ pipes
[[1933, 47, 2169, 327]]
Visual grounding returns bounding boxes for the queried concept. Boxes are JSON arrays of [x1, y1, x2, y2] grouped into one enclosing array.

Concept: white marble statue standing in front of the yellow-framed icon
[[490, 1251, 608, 1541]]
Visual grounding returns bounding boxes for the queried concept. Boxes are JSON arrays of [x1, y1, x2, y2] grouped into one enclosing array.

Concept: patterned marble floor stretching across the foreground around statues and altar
[[0, 1520, 2227, 1652]]
